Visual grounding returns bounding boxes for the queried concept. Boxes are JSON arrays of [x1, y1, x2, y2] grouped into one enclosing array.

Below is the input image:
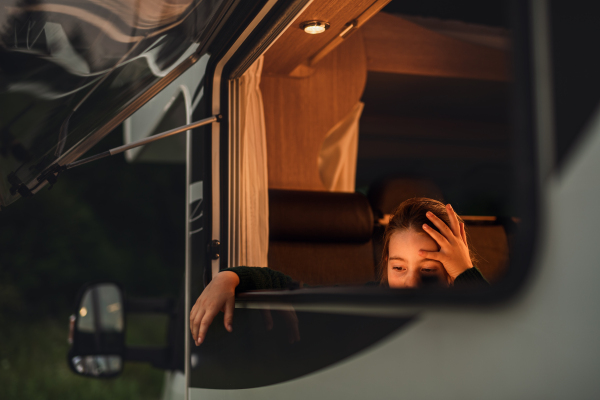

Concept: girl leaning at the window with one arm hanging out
[[190, 197, 487, 346]]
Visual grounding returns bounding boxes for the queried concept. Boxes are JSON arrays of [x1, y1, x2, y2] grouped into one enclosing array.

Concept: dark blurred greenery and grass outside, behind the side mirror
[[0, 132, 185, 400]]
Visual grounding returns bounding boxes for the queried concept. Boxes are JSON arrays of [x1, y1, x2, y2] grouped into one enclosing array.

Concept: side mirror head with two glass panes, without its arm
[[68, 283, 125, 378]]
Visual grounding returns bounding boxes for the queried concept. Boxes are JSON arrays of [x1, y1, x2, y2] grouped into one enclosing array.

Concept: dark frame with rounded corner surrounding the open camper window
[[207, 0, 545, 307]]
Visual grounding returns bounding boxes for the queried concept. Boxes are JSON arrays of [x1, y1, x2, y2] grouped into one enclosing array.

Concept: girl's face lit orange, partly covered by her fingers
[[387, 229, 448, 288]]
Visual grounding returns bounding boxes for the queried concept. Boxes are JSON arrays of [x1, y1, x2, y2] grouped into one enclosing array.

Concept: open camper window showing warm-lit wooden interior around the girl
[[216, 2, 530, 298]]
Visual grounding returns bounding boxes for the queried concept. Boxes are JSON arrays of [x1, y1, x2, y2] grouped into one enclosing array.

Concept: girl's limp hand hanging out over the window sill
[[190, 271, 240, 346]]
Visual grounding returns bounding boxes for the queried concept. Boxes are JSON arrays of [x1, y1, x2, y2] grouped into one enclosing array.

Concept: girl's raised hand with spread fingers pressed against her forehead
[[419, 204, 473, 283]]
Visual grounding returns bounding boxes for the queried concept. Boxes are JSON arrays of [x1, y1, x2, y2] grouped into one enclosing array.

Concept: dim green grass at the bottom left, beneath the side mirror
[[0, 315, 164, 400]]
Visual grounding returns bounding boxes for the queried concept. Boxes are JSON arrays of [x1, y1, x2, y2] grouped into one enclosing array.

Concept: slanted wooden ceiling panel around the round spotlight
[[263, 0, 376, 75]]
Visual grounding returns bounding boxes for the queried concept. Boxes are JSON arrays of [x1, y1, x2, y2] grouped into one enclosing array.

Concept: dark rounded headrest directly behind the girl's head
[[368, 178, 444, 214]]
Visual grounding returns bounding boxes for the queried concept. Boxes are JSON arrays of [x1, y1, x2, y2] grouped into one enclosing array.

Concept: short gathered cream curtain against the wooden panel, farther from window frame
[[318, 102, 365, 192]]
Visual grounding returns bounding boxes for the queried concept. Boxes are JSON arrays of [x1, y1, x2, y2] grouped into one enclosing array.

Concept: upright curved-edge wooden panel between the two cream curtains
[[260, 31, 367, 190]]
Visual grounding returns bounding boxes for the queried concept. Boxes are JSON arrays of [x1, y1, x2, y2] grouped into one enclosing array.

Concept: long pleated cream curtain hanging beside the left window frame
[[238, 57, 269, 267]]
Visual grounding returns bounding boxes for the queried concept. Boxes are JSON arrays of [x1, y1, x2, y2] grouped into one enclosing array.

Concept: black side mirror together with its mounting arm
[[67, 282, 180, 378]]
